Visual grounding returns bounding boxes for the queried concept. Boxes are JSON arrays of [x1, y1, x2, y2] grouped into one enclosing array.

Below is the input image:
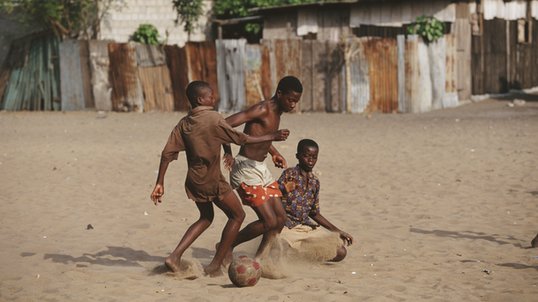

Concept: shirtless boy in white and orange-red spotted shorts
[[225, 76, 303, 258]]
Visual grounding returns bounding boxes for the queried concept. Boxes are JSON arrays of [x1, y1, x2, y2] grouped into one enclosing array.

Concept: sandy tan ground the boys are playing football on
[[0, 98, 538, 302]]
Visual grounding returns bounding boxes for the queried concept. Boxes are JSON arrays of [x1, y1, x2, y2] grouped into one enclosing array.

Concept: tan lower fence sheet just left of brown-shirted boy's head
[[138, 65, 174, 112]]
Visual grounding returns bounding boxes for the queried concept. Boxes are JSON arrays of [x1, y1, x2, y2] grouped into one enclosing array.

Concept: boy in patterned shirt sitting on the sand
[[278, 139, 353, 261]]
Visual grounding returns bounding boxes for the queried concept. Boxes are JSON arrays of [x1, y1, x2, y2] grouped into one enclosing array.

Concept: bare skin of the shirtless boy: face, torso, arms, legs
[[220, 90, 301, 260]]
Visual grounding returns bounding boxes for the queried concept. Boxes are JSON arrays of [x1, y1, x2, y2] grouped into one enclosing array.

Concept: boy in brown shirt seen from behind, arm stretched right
[[151, 81, 289, 276]]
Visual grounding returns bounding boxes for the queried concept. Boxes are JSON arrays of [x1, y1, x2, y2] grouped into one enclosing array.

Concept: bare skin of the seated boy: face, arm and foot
[[288, 146, 353, 261]]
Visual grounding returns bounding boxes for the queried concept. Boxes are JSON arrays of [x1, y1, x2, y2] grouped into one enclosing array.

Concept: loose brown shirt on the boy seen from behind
[[161, 106, 247, 202]]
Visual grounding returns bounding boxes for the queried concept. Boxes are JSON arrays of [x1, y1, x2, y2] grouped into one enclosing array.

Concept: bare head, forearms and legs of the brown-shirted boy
[[150, 87, 289, 277]]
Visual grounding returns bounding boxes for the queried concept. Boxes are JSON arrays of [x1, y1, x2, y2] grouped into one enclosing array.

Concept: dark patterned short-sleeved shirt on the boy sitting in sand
[[278, 165, 320, 229]]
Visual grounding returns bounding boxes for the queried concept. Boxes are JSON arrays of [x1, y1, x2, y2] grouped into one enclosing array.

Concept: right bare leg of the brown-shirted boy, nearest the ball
[[204, 191, 245, 276]]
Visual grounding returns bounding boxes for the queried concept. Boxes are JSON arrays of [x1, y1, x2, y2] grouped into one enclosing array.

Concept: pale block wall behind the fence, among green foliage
[[98, 0, 213, 46]]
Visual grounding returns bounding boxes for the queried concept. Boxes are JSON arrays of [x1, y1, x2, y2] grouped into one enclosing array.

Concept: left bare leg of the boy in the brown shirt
[[164, 202, 214, 272]]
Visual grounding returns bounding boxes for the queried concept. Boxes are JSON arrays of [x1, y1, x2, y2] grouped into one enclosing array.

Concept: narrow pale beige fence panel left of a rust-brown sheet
[[89, 40, 112, 111]]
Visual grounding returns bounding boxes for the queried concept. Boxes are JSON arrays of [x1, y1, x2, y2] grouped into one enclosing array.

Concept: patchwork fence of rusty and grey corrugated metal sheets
[[4, 31, 538, 113]]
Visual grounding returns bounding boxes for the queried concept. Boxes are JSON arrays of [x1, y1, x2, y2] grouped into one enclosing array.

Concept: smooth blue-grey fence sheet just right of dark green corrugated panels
[[59, 40, 86, 111]]
